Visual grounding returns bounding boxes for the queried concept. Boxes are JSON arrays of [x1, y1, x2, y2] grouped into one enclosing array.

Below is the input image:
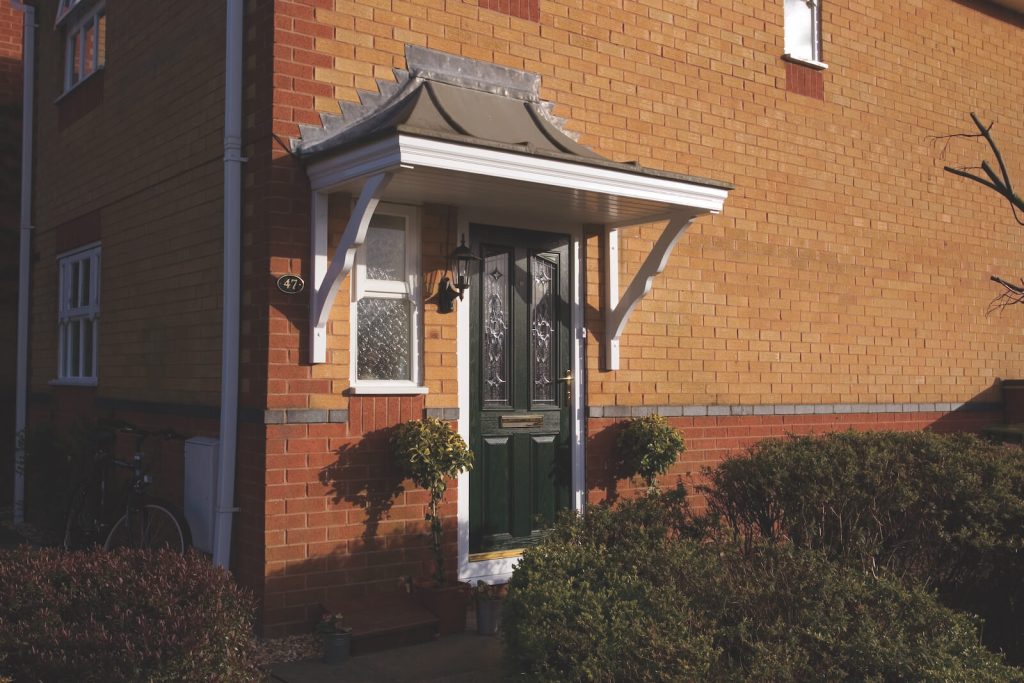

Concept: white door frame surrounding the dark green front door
[[456, 210, 587, 584]]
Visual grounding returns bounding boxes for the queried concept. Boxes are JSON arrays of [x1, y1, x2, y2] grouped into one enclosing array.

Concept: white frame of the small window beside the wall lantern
[[349, 204, 427, 394]]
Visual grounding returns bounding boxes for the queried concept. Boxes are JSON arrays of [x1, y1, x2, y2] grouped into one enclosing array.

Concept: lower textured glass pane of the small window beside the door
[[355, 297, 412, 380]]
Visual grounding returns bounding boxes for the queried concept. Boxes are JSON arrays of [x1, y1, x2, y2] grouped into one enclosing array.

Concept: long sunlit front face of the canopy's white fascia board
[[398, 135, 729, 213]]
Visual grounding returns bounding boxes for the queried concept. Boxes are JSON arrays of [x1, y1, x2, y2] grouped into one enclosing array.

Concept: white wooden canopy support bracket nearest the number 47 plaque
[[309, 173, 391, 364]]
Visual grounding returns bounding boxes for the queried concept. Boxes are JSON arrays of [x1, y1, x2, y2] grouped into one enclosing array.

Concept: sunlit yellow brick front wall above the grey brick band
[[294, 0, 1024, 405]]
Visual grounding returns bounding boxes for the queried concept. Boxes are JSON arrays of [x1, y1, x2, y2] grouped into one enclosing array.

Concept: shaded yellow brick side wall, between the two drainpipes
[[31, 1, 224, 405]]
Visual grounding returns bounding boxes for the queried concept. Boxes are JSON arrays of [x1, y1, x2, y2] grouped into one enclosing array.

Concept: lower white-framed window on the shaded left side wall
[[57, 245, 99, 384]]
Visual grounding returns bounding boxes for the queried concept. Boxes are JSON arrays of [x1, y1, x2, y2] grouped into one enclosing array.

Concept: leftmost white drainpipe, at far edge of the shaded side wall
[[10, 0, 36, 524]]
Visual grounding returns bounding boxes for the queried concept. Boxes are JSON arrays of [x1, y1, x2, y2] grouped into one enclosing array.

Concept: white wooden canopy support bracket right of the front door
[[604, 213, 698, 370]]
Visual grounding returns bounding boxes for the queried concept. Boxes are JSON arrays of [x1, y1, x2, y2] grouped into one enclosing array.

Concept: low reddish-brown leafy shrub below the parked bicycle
[[0, 548, 259, 681]]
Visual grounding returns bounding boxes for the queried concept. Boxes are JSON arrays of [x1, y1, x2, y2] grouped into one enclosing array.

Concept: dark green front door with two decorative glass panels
[[469, 225, 572, 557]]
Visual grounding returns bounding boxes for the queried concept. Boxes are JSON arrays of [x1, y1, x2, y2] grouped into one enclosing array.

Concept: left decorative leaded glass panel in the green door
[[482, 252, 510, 405]]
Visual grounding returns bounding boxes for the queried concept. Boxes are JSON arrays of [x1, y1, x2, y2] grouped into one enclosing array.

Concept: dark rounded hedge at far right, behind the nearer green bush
[[701, 432, 1024, 660]]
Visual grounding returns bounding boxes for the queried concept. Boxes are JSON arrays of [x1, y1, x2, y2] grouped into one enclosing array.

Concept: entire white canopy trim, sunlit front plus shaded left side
[[307, 135, 729, 216]]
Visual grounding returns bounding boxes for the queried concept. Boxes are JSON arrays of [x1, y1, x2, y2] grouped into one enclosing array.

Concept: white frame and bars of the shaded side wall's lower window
[[55, 244, 101, 385]]
